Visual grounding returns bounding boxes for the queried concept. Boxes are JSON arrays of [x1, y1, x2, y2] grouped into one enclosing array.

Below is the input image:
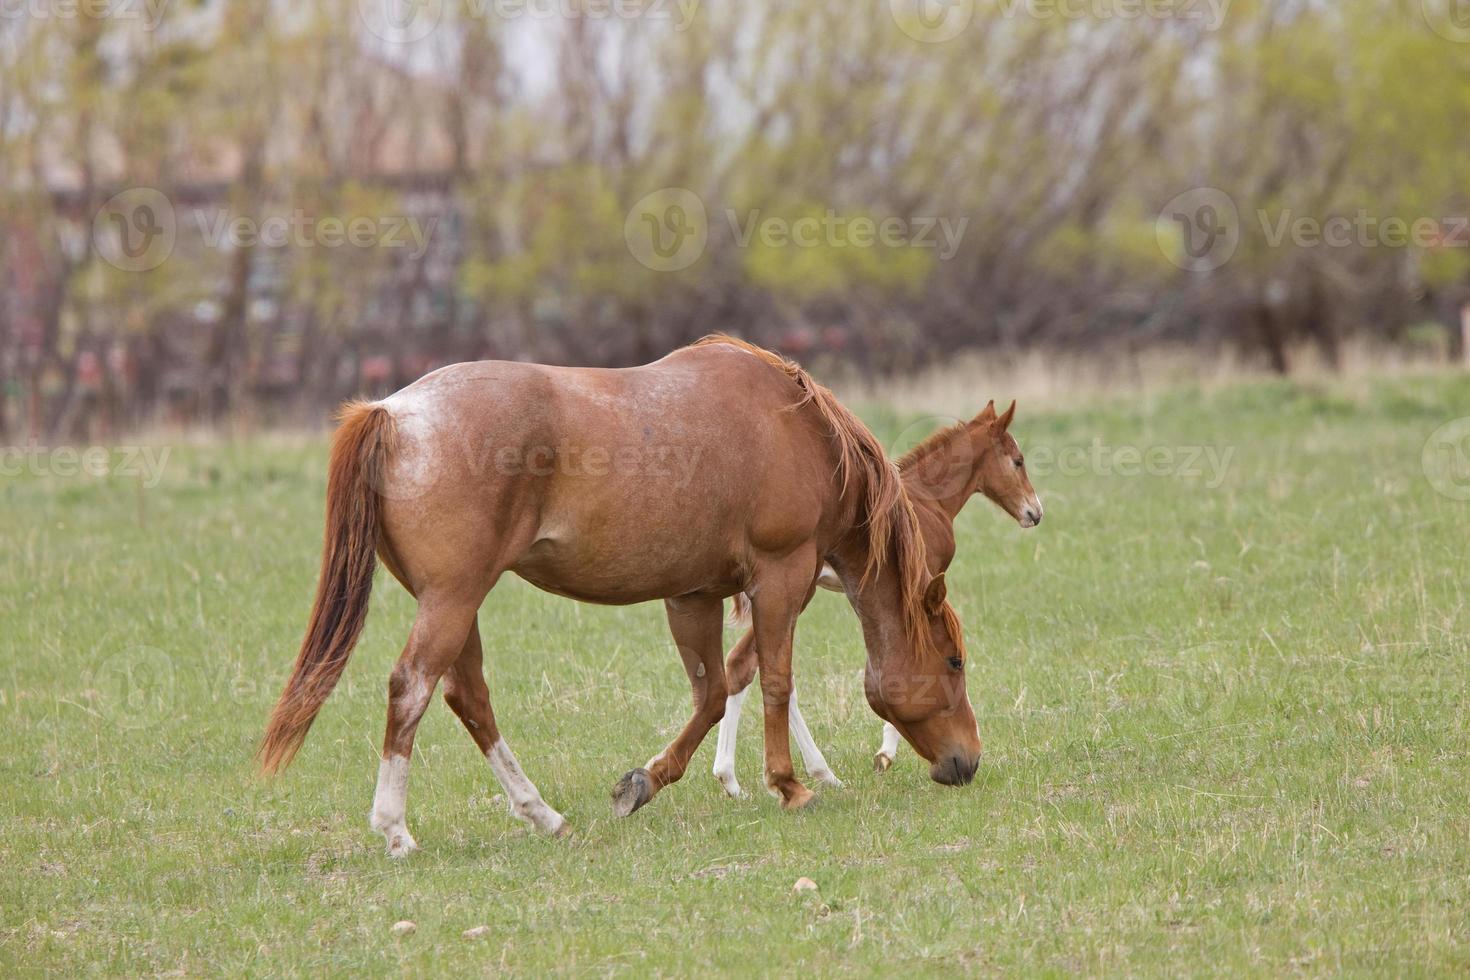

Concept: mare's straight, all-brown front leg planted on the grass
[[753, 554, 816, 810]]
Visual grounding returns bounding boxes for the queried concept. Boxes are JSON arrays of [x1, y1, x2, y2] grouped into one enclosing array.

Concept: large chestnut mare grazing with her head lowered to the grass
[[260, 336, 980, 855]]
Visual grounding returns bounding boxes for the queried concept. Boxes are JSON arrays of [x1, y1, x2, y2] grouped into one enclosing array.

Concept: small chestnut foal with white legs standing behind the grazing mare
[[713, 401, 1041, 796]]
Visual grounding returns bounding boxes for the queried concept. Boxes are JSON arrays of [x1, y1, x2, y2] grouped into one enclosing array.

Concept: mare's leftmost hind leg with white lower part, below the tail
[[370, 595, 479, 858]]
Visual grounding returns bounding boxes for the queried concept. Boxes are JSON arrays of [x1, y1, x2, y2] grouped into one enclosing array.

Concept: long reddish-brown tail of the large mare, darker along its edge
[[257, 401, 394, 773]]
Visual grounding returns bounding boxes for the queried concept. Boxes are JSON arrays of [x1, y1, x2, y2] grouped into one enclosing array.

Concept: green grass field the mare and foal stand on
[[0, 375, 1470, 976]]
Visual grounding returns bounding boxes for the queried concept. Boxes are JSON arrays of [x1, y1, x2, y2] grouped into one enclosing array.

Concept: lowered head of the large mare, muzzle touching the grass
[[863, 573, 980, 786]]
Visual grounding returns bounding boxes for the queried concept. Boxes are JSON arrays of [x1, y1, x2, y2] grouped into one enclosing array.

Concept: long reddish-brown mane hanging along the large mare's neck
[[689, 334, 964, 664]]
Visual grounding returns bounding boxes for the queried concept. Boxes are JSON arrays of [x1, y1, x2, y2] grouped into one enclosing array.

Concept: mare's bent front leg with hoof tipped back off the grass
[[613, 598, 726, 817]]
